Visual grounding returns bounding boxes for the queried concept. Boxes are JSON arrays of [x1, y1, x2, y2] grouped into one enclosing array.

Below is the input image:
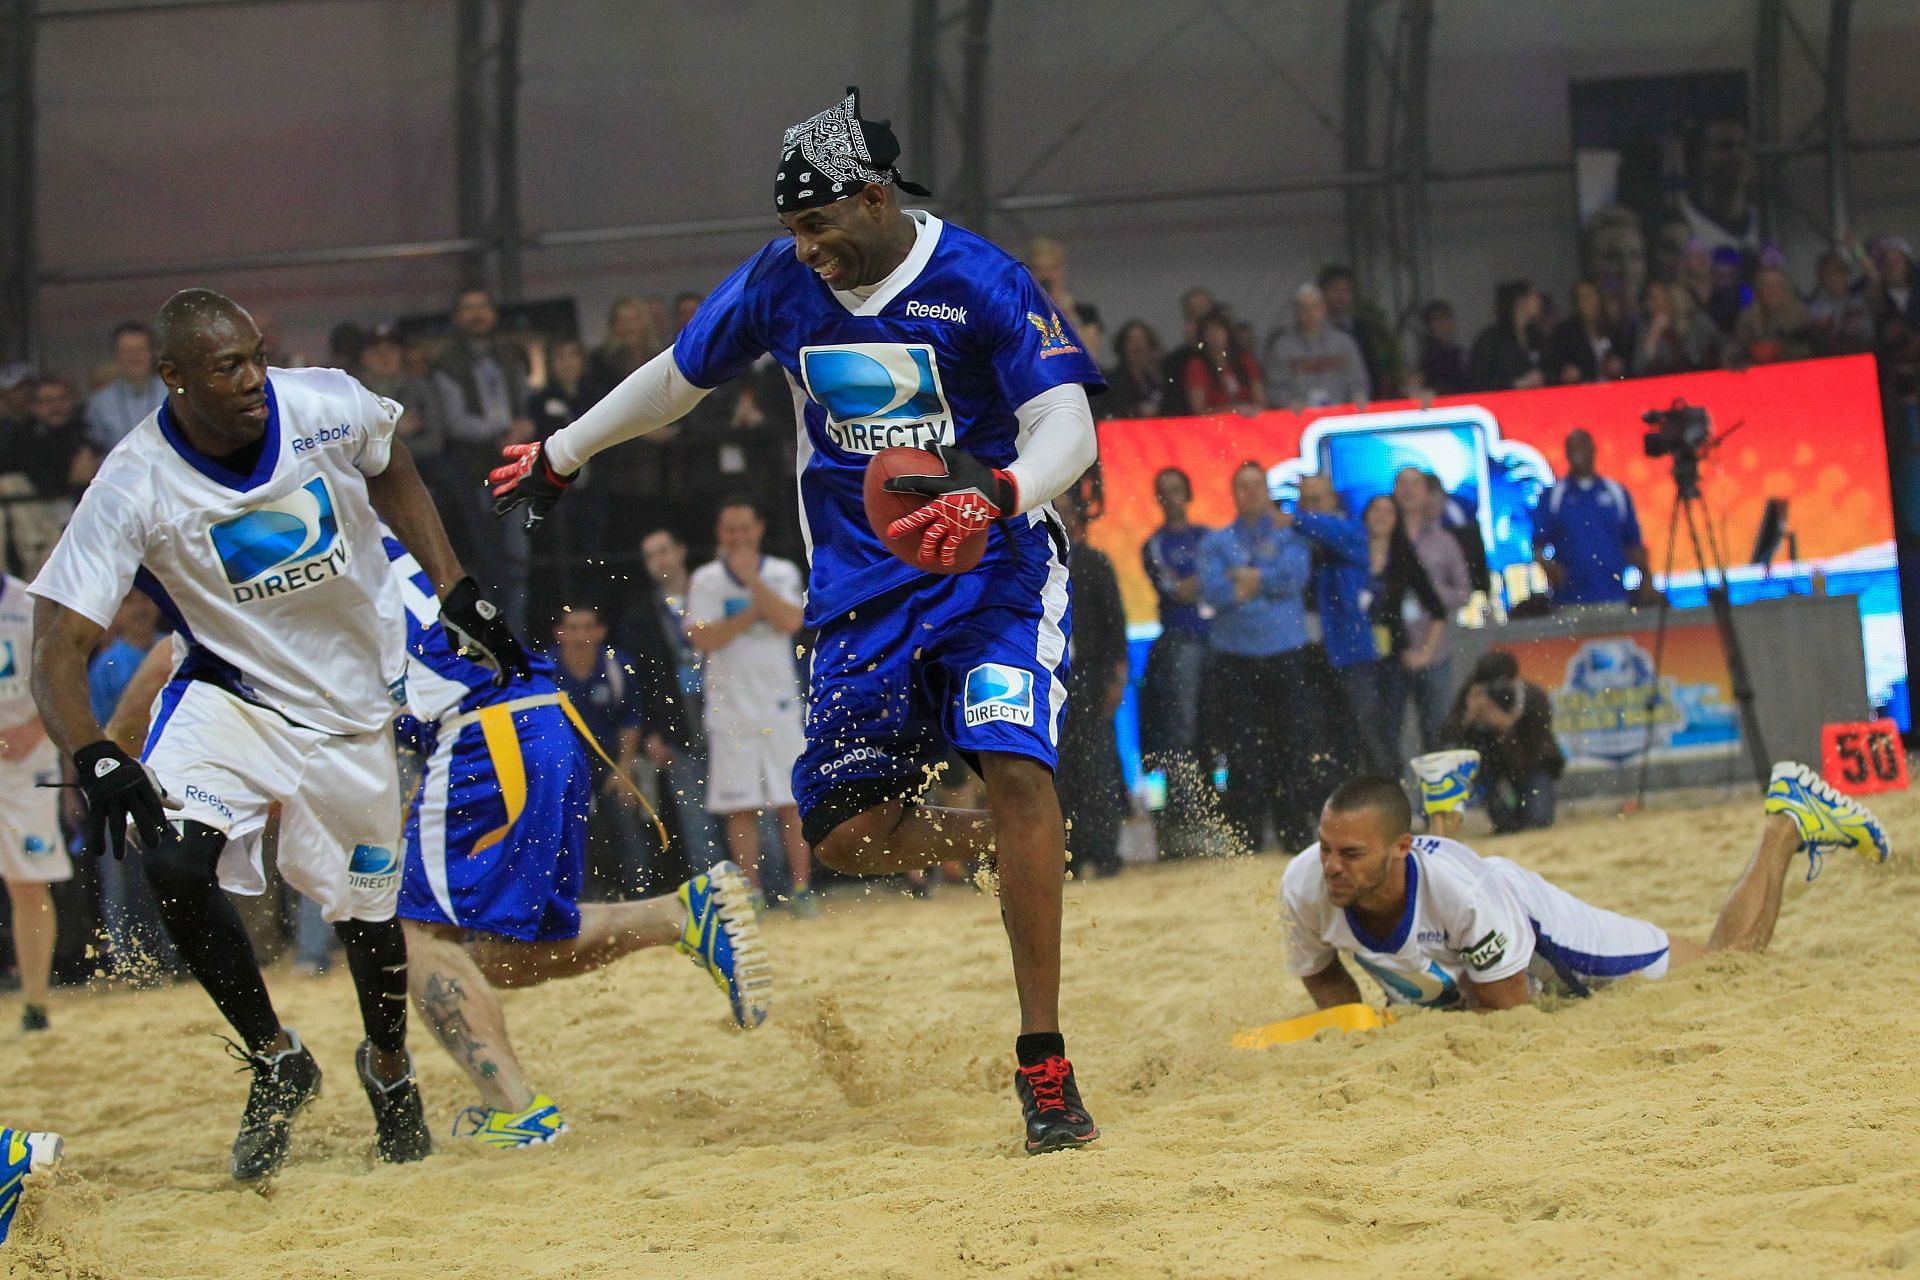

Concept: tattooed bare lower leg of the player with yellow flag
[[401, 919, 534, 1111]]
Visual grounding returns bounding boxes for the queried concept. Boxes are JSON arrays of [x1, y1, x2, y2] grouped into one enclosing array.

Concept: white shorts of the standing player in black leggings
[[142, 679, 401, 921]]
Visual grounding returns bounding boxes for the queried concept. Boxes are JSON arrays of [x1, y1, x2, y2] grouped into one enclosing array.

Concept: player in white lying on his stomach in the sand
[[1281, 764, 1891, 1009]]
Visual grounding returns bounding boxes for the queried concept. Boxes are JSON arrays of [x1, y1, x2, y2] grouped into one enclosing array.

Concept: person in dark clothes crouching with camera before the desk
[[1440, 649, 1567, 833]]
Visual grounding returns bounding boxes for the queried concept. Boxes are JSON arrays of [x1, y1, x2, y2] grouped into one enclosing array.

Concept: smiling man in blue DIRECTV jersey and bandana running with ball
[[495, 90, 1104, 1151]]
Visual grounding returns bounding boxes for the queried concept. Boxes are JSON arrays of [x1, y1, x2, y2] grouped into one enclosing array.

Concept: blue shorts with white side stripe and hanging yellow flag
[[399, 704, 593, 942]]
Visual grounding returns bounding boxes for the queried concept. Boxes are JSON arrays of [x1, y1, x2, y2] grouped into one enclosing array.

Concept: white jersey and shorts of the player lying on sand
[[1281, 835, 1667, 1007]]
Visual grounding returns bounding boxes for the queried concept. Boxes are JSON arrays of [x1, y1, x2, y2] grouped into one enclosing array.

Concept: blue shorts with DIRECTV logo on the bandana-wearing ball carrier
[[793, 521, 1073, 844]]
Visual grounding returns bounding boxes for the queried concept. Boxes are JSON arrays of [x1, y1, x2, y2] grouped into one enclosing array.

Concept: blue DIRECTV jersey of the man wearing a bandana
[[674, 209, 1106, 626]]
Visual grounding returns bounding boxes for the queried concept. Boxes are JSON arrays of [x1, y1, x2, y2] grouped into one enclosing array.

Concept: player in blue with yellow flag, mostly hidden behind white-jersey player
[[113, 537, 774, 1148]]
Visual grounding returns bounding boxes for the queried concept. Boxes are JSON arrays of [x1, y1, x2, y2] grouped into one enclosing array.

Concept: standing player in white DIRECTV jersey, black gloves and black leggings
[[31, 290, 526, 1180]]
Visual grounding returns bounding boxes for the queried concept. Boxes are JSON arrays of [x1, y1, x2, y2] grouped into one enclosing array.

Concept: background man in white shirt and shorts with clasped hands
[[687, 499, 818, 913]]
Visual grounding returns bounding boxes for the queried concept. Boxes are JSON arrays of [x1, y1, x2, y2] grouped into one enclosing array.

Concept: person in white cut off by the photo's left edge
[[0, 574, 73, 1031]]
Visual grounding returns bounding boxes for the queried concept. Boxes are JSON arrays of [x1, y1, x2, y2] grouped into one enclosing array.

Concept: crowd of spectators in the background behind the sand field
[[0, 195, 1920, 990]]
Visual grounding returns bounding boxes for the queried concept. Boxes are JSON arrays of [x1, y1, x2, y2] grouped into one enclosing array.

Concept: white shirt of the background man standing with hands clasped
[[687, 557, 804, 733]]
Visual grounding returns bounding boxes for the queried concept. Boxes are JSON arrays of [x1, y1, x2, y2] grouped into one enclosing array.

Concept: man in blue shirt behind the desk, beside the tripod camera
[[1534, 428, 1657, 604]]
